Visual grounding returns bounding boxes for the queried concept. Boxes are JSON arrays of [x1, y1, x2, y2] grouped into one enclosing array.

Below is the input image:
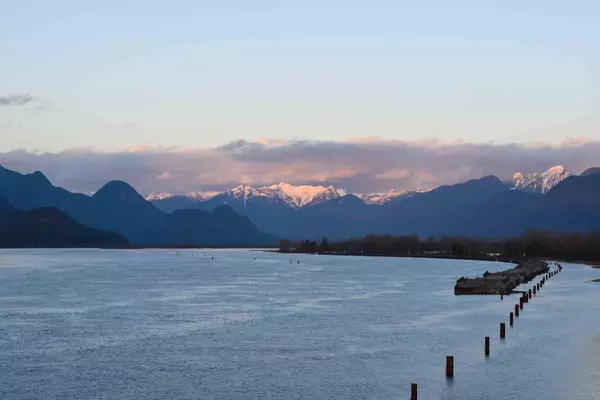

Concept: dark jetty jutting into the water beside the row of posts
[[454, 260, 550, 295]]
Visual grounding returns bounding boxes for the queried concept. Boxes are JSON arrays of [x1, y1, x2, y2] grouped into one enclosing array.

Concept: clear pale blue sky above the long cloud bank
[[0, 0, 600, 151]]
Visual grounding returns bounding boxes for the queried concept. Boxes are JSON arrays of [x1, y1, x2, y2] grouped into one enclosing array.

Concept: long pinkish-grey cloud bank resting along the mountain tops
[[0, 138, 600, 194]]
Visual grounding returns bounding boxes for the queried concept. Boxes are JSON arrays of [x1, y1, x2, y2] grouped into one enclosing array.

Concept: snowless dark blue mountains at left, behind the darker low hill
[[0, 167, 277, 246]]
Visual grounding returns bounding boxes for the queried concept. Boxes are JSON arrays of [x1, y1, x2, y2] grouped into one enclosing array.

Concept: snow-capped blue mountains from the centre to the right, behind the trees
[[142, 166, 600, 239]]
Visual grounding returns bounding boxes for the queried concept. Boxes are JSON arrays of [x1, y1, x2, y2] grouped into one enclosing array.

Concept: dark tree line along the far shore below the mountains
[[279, 231, 600, 261]]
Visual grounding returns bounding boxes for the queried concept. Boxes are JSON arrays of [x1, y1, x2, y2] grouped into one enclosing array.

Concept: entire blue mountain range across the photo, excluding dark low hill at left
[[0, 163, 600, 246]]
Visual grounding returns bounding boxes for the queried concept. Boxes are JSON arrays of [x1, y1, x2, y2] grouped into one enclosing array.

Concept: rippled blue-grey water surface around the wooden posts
[[0, 250, 600, 400]]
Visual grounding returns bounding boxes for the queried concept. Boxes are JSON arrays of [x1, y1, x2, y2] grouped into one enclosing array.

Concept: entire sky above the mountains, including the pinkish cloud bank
[[0, 0, 600, 192]]
